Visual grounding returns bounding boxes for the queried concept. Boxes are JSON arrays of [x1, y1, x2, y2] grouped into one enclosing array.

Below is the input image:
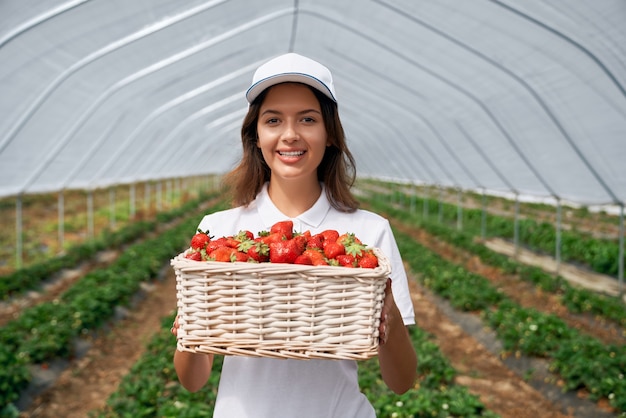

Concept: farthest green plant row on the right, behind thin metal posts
[[368, 185, 619, 277]]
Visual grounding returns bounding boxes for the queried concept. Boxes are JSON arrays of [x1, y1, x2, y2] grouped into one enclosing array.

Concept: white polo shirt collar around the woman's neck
[[256, 183, 331, 231]]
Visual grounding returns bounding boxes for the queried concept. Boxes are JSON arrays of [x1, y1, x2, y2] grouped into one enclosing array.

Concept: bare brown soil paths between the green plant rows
[[7, 212, 626, 418]]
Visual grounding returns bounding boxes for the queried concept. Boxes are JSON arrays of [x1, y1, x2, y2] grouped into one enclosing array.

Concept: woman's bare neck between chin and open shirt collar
[[268, 178, 322, 218]]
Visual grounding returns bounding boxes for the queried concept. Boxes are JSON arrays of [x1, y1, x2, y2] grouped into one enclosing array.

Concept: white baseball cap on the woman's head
[[246, 53, 337, 103]]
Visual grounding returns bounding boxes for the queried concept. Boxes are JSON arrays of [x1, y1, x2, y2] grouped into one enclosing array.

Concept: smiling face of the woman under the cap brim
[[257, 83, 329, 181]]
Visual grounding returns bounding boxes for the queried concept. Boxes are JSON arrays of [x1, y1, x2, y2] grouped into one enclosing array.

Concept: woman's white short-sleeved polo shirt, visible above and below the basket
[[199, 184, 415, 418]]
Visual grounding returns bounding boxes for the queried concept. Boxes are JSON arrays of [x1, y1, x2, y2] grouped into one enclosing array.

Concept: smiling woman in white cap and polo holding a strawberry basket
[[172, 54, 417, 418]]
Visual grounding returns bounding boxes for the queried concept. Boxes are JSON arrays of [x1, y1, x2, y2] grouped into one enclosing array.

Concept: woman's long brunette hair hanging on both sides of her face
[[223, 86, 359, 212]]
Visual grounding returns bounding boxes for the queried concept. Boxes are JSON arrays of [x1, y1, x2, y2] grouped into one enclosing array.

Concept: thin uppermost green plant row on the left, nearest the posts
[[0, 196, 217, 300]]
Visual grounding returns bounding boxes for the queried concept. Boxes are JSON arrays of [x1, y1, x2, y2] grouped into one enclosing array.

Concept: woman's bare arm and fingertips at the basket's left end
[[172, 317, 213, 392]]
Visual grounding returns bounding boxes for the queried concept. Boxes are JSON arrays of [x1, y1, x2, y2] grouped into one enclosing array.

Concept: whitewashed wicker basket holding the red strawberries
[[172, 249, 391, 360]]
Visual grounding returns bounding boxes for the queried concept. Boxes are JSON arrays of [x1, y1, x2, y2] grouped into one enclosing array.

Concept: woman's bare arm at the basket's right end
[[378, 280, 417, 394]]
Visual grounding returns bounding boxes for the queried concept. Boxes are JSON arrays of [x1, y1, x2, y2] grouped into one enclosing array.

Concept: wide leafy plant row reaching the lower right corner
[[396, 233, 626, 412]]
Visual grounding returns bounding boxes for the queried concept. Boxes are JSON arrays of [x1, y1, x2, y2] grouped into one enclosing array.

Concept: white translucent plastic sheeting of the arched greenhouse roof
[[0, 0, 626, 206]]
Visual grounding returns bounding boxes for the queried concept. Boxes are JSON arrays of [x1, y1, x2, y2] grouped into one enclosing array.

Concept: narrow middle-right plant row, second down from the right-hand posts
[[368, 194, 626, 327]]
